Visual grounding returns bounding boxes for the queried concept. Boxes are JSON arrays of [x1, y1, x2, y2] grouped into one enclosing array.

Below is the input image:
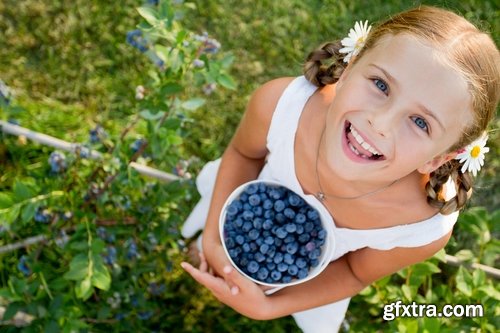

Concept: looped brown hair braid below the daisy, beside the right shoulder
[[425, 160, 473, 215]]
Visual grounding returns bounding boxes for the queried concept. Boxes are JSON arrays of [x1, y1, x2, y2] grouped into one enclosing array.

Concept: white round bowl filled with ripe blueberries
[[219, 180, 334, 287]]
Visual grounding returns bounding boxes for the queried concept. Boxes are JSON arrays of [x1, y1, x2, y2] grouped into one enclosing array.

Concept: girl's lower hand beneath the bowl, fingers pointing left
[[181, 253, 271, 320]]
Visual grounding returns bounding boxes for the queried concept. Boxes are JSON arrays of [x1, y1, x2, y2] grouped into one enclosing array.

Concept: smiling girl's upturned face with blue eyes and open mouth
[[325, 35, 472, 183]]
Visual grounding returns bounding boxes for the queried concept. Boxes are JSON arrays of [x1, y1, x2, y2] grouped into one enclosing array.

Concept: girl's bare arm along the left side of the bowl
[[199, 78, 293, 275]]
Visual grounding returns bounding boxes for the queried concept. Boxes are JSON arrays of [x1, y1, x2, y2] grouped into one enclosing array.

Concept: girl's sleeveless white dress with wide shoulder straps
[[181, 76, 458, 333]]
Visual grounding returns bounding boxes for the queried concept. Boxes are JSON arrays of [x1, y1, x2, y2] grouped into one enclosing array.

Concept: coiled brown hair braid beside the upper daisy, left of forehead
[[304, 41, 346, 87]]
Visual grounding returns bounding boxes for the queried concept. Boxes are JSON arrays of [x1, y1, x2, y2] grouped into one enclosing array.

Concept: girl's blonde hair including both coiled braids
[[304, 6, 500, 214]]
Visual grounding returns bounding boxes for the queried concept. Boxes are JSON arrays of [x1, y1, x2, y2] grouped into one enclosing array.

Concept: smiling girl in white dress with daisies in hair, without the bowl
[[182, 7, 500, 333]]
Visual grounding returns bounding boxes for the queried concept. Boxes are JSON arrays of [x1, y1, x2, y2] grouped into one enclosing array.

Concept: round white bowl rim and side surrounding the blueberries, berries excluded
[[219, 179, 335, 289]]
